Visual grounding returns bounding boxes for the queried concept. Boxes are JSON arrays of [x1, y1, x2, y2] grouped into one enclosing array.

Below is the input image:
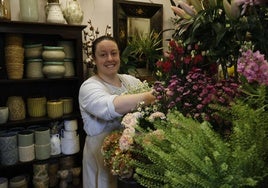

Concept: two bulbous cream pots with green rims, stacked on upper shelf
[[42, 46, 65, 78]]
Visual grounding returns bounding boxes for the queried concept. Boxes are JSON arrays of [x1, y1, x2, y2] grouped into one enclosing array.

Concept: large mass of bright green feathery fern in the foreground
[[134, 94, 268, 188]]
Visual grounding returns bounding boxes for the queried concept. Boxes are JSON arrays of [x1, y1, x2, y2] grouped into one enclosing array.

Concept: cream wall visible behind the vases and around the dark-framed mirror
[[10, 0, 173, 46]]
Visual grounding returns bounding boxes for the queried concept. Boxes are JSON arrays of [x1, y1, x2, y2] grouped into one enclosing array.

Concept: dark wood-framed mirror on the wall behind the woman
[[113, 0, 163, 52]]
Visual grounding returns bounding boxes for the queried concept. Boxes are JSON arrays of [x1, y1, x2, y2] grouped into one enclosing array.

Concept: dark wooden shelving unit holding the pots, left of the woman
[[0, 21, 86, 187]]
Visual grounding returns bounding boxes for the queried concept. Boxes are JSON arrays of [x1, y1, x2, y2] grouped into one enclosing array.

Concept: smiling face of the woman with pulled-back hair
[[94, 40, 120, 76]]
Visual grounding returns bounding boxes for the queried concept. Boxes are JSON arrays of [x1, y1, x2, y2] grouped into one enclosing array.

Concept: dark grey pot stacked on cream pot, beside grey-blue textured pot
[[18, 130, 35, 162]]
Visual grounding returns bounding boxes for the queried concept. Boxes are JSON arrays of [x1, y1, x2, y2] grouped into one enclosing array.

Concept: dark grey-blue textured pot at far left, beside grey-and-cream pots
[[0, 132, 19, 165]]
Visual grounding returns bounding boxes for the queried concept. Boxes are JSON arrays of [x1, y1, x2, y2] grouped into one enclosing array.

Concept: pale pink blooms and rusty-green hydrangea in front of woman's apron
[[101, 112, 165, 179]]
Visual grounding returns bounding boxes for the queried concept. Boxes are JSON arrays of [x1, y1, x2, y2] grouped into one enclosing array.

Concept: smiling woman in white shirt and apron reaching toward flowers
[[79, 36, 155, 188]]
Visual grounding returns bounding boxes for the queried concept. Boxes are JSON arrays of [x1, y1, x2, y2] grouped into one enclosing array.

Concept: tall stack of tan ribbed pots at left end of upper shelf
[[5, 34, 24, 79]]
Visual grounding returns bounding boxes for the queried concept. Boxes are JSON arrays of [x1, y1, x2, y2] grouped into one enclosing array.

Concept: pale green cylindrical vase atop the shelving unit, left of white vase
[[20, 0, 39, 22]]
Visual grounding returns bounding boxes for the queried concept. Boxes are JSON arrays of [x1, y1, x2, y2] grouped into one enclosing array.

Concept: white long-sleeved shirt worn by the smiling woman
[[78, 74, 141, 136]]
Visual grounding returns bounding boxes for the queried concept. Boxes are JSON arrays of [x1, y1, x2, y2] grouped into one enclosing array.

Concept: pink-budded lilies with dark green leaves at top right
[[171, 0, 268, 77]]
